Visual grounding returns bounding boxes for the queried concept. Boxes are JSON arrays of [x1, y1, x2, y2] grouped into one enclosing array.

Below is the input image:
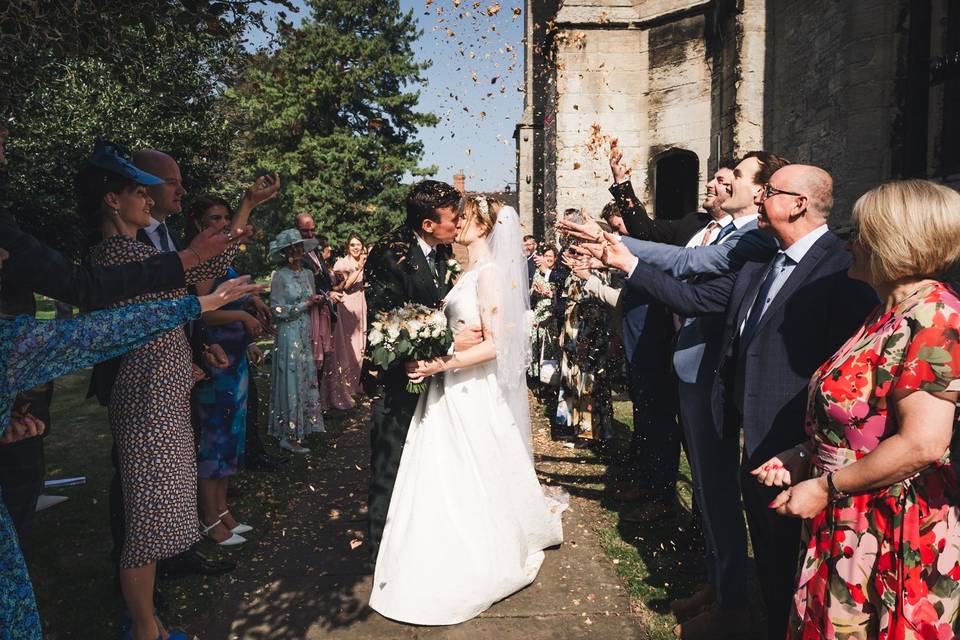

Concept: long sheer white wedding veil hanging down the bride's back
[[487, 205, 533, 460]]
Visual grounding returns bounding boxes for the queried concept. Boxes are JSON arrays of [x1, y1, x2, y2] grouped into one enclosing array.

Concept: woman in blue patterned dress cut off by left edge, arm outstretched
[[0, 244, 258, 640]]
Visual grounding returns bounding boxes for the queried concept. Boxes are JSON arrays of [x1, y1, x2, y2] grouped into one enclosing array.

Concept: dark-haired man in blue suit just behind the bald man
[[624, 151, 789, 626]]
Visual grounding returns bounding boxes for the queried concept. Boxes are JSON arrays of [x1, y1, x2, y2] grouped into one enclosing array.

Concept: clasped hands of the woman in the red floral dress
[[750, 445, 830, 518]]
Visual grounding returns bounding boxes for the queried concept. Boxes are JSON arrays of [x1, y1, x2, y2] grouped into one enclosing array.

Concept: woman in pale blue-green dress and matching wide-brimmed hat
[[268, 229, 324, 453]]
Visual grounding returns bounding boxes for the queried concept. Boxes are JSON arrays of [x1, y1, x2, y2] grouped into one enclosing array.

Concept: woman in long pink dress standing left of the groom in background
[[321, 233, 367, 409]]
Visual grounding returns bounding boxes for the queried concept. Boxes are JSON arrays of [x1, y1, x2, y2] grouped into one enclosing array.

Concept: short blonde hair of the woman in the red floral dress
[[853, 180, 960, 282]]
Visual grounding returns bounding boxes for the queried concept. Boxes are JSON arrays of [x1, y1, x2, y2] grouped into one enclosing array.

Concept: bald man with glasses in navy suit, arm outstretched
[[590, 165, 876, 639]]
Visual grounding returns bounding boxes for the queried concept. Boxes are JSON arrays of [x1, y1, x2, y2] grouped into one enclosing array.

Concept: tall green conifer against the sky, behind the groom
[[229, 0, 437, 258]]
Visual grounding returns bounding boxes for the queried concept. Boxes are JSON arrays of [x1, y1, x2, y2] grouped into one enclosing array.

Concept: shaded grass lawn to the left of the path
[[25, 362, 342, 640]]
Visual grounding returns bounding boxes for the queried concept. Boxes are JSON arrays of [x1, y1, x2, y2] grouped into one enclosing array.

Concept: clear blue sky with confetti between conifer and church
[[244, 0, 523, 191]]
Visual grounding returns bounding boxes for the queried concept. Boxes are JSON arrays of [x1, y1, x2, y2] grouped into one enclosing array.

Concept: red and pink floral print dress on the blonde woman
[[788, 282, 960, 640]]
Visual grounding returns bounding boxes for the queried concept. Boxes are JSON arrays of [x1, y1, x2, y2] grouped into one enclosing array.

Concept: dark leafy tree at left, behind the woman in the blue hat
[[0, 21, 243, 257]]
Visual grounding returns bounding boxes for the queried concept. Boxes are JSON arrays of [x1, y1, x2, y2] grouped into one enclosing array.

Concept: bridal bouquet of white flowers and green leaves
[[367, 303, 453, 393]]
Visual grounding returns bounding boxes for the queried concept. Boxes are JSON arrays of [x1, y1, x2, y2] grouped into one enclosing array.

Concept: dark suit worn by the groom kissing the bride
[[364, 225, 451, 562]]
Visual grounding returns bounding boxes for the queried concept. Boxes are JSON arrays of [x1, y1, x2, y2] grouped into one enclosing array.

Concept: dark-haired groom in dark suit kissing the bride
[[364, 180, 482, 564]]
